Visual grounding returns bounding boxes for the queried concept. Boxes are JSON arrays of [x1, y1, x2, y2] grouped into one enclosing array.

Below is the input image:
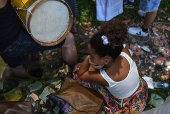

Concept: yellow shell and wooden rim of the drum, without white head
[[11, 0, 73, 46]]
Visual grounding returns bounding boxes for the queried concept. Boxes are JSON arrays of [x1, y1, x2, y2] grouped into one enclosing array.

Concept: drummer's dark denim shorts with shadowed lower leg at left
[[1, 29, 64, 78]]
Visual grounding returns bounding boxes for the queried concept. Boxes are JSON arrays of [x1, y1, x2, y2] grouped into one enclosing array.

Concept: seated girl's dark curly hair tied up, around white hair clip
[[90, 21, 127, 60]]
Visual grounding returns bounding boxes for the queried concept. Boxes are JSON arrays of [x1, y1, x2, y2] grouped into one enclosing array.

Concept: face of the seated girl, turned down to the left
[[88, 44, 104, 65]]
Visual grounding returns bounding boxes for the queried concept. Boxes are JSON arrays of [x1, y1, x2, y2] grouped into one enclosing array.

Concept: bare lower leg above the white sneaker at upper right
[[143, 11, 157, 29]]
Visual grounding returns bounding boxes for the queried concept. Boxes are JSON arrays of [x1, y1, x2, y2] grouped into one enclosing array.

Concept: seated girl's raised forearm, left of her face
[[78, 56, 90, 77]]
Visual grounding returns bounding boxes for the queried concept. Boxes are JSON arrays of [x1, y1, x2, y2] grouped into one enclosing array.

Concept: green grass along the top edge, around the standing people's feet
[[77, 0, 170, 27]]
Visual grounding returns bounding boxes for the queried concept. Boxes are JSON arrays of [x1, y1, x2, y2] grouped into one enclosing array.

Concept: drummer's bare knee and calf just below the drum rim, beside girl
[[61, 33, 77, 69]]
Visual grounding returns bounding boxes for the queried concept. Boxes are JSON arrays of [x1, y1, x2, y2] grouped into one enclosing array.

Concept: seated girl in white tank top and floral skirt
[[73, 21, 148, 114]]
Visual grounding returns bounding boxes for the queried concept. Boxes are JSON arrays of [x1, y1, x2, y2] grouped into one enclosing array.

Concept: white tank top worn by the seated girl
[[100, 52, 140, 99]]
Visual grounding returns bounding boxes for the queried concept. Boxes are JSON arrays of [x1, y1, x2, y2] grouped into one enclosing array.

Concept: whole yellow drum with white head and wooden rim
[[11, 0, 73, 46]]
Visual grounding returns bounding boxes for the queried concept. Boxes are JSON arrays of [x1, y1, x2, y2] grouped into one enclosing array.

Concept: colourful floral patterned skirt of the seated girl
[[73, 63, 148, 114]]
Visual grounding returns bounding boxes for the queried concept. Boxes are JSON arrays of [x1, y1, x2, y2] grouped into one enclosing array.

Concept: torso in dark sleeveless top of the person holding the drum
[[0, 0, 22, 52]]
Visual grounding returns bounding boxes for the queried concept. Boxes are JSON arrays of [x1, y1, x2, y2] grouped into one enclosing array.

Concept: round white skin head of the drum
[[30, 1, 70, 43]]
